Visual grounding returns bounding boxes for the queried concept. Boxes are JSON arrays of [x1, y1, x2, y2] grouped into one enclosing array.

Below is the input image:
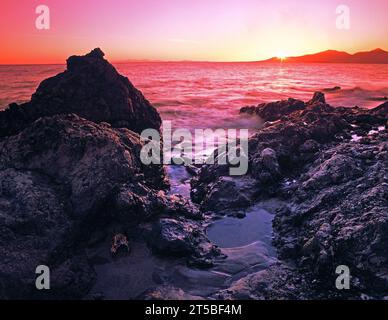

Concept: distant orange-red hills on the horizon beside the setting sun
[[264, 49, 388, 64]]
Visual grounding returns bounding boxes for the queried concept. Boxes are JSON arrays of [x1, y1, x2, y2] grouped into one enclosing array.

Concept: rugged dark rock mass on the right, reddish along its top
[[199, 93, 388, 299]]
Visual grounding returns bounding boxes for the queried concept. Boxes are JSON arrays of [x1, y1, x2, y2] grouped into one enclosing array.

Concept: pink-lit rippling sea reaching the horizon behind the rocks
[[0, 62, 388, 129]]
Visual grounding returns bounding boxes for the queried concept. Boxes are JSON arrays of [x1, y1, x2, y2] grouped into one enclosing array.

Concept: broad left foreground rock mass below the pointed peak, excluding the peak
[[0, 114, 209, 299]]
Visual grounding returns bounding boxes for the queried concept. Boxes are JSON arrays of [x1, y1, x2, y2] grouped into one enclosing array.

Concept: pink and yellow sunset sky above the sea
[[0, 0, 388, 64]]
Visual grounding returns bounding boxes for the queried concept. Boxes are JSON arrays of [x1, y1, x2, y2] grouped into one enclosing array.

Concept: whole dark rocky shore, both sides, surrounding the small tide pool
[[0, 49, 388, 299]]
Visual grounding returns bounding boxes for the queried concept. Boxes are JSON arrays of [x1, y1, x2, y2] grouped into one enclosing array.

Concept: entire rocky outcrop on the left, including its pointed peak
[[0, 49, 215, 299]]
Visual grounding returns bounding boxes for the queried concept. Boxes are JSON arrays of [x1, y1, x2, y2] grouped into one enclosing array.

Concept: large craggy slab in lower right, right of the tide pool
[[274, 133, 388, 297]]
